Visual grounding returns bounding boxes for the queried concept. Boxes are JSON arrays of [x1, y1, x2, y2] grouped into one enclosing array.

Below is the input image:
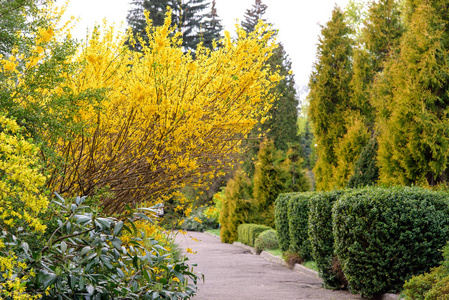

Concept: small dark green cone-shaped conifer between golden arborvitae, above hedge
[[347, 137, 379, 188]]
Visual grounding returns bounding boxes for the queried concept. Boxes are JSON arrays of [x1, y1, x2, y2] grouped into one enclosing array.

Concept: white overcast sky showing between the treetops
[[60, 0, 349, 96]]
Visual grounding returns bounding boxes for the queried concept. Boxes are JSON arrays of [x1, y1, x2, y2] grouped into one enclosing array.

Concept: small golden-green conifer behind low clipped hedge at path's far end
[[220, 170, 252, 244]]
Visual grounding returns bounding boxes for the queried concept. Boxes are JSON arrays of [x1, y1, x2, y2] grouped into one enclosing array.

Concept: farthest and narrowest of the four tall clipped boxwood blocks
[[274, 193, 296, 252]]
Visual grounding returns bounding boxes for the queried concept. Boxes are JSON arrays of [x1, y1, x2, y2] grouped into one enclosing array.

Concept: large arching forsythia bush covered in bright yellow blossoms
[[52, 13, 279, 211]]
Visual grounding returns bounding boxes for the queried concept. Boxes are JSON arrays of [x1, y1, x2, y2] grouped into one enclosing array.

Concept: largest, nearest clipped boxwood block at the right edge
[[332, 187, 449, 297]]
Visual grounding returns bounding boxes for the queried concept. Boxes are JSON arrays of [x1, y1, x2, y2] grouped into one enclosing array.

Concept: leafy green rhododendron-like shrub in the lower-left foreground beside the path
[[1, 195, 198, 299]]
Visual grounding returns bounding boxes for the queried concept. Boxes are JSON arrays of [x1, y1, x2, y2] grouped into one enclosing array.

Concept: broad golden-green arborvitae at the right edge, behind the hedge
[[377, 0, 449, 186]]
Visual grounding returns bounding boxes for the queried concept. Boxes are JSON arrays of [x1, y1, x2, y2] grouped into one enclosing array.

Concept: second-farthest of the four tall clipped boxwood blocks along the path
[[288, 192, 315, 261]]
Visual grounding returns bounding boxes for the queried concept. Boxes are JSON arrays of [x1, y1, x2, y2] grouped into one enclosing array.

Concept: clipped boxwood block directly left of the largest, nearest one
[[309, 190, 349, 289]]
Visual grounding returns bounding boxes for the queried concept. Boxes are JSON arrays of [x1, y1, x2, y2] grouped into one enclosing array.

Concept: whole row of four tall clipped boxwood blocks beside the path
[[276, 187, 449, 297]]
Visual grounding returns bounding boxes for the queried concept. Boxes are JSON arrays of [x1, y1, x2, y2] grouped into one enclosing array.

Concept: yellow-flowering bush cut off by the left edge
[[0, 115, 48, 299]]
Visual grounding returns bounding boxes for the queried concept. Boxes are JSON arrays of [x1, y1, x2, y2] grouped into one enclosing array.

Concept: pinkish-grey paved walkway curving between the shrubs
[[176, 232, 361, 300]]
